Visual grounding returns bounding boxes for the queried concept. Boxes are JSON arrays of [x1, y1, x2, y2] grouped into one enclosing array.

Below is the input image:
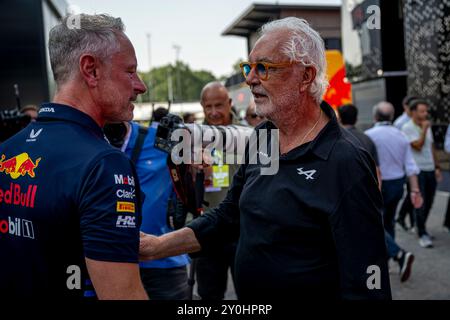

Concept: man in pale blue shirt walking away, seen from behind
[[365, 102, 422, 282]]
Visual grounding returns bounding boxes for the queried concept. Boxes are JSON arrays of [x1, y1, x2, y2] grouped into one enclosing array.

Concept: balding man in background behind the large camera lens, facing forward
[[196, 82, 239, 300]]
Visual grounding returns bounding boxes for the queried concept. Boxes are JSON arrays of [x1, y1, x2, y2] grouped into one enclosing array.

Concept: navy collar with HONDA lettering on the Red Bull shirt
[[36, 103, 104, 139]]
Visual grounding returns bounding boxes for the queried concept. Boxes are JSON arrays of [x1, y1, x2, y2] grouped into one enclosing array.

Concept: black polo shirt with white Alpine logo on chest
[[188, 103, 391, 299]]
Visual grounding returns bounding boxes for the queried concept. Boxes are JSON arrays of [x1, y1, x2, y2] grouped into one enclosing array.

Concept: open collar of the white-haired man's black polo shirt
[[267, 101, 342, 160]]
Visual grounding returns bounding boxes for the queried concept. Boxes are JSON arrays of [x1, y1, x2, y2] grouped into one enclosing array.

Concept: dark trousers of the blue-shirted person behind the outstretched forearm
[[140, 266, 189, 300]]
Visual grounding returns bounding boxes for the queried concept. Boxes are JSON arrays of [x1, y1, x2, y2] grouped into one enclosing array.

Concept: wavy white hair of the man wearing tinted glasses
[[260, 17, 328, 103]]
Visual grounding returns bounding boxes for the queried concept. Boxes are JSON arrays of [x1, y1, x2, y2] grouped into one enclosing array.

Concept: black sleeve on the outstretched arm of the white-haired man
[[187, 165, 245, 254]]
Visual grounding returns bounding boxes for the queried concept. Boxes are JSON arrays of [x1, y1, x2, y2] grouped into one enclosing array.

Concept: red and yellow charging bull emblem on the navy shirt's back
[[0, 152, 41, 179]]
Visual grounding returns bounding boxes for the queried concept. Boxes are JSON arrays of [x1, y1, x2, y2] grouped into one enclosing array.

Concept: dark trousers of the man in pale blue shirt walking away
[[381, 178, 405, 239]]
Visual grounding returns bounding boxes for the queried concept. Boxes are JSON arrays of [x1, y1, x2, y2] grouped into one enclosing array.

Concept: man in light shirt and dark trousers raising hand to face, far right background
[[402, 100, 441, 248]]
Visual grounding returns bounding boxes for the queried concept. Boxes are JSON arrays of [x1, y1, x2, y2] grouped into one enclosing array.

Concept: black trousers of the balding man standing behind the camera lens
[[195, 244, 236, 301]]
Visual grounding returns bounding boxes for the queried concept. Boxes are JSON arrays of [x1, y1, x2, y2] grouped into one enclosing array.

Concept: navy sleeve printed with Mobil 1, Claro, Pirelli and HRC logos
[[79, 152, 142, 263]]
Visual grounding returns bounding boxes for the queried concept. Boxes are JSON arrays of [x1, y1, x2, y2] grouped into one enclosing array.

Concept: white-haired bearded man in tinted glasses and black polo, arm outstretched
[[140, 17, 391, 299]]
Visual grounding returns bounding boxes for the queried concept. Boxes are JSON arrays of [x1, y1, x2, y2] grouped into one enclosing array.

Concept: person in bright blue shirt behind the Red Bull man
[[105, 108, 189, 300]]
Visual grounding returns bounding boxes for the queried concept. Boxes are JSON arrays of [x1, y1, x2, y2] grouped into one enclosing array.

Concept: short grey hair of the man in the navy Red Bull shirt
[[48, 14, 125, 85]]
